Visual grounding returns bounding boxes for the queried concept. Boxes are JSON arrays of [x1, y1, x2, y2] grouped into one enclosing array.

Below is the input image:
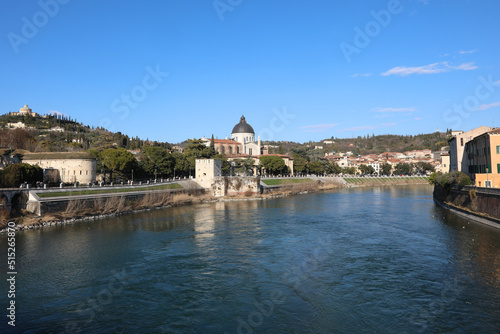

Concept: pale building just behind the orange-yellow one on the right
[[448, 125, 493, 172]]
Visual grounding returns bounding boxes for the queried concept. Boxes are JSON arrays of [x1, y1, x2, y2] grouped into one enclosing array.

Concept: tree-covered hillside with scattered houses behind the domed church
[[0, 114, 448, 157]]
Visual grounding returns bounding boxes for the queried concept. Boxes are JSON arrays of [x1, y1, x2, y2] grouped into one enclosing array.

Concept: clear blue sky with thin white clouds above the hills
[[0, 0, 500, 143]]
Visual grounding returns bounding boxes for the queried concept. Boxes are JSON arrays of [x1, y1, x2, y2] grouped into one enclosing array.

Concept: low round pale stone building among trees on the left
[[21, 152, 97, 183]]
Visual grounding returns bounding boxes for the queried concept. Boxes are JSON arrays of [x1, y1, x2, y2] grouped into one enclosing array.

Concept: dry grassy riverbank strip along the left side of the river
[[0, 177, 427, 233]]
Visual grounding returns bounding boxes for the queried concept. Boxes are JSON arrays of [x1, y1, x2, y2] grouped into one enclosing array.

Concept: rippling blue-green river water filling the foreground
[[0, 185, 500, 333]]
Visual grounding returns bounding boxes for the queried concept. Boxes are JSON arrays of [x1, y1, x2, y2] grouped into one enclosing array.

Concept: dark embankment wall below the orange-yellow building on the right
[[433, 184, 500, 220]]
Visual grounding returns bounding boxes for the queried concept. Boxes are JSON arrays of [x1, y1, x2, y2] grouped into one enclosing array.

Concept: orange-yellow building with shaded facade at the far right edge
[[464, 128, 500, 188]]
